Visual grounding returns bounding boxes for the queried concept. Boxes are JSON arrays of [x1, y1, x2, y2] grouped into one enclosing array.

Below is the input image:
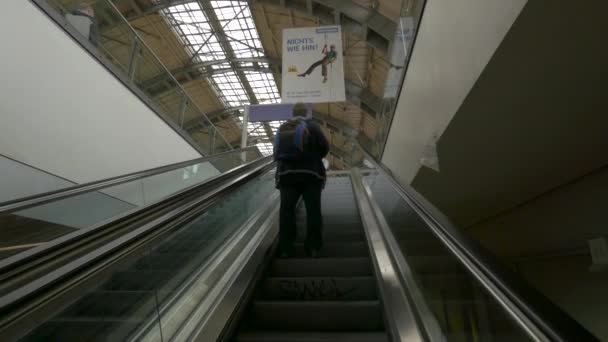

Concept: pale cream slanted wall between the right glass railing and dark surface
[[382, 0, 526, 184]]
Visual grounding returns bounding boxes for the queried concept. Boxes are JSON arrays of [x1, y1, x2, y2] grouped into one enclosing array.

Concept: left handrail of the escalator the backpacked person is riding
[[0, 157, 274, 313]]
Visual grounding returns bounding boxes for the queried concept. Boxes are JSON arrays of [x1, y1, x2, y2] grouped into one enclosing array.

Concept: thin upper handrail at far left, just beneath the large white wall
[[0, 146, 262, 214]]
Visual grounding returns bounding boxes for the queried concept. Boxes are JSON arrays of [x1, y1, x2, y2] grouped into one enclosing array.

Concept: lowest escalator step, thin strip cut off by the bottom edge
[[236, 331, 389, 342]]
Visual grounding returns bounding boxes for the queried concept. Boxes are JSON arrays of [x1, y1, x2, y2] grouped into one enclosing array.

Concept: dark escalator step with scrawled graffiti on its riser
[[260, 277, 378, 301]]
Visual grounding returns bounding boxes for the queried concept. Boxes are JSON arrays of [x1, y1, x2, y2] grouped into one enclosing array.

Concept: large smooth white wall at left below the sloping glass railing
[[0, 0, 200, 187]]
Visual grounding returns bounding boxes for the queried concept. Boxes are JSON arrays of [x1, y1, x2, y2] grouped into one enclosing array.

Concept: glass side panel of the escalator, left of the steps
[[18, 174, 271, 341]]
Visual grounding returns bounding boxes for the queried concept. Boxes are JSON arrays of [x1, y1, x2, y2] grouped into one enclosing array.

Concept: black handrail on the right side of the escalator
[[354, 142, 599, 342]]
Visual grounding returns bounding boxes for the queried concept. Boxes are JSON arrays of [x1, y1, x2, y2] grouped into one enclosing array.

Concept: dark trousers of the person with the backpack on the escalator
[[279, 180, 323, 254]]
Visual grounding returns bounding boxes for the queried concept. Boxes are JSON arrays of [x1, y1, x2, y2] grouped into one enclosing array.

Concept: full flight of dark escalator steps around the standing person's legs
[[234, 177, 388, 342]]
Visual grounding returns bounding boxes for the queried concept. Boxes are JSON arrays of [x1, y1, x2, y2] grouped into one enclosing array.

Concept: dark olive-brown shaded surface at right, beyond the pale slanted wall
[[389, 1, 608, 227]]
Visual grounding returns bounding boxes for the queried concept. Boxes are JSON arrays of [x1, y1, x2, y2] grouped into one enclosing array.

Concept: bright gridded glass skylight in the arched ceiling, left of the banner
[[157, 0, 281, 154]]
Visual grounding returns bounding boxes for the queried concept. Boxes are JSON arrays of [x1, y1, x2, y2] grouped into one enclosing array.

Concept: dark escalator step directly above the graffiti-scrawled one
[[270, 258, 373, 277]]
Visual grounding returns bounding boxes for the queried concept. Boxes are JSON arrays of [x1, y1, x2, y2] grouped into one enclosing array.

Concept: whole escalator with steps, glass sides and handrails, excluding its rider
[[0, 148, 597, 342]]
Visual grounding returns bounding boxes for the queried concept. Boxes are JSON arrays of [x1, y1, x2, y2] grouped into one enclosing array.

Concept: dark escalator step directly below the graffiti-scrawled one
[[247, 301, 384, 332]]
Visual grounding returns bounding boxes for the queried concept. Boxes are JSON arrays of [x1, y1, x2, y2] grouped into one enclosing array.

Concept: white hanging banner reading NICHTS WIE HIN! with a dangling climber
[[282, 26, 346, 103]]
